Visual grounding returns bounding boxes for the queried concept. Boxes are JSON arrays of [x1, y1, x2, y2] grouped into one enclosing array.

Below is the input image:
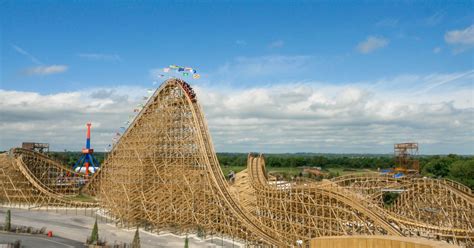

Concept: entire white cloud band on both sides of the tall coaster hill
[[0, 71, 474, 153]]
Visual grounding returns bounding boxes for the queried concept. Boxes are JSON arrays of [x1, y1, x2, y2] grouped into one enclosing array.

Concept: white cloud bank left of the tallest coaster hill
[[0, 87, 147, 151]]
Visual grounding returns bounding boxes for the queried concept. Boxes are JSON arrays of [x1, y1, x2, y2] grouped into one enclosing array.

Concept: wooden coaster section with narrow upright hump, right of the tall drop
[[247, 155, 401, 246]]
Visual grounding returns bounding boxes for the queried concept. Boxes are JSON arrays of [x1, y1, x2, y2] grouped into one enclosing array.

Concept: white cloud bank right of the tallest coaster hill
[[197, 75, 474, 153]]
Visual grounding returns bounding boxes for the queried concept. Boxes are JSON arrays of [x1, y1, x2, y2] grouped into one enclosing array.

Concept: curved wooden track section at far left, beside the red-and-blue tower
[[0, 152, 97, 208]]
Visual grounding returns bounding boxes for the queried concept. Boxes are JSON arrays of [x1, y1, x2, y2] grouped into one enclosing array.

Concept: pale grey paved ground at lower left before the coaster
[[0, 207, 242, 248]]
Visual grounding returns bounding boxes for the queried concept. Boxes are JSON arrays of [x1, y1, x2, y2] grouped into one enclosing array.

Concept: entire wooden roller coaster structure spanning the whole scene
[[0, 79, 474, 247]]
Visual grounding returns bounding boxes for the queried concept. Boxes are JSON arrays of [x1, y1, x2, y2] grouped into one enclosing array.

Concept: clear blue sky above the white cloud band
[[0, 1, 474, 153]]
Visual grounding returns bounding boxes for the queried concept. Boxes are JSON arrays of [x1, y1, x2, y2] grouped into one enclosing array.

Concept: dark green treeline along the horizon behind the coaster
[[45, 152, 474, 189]]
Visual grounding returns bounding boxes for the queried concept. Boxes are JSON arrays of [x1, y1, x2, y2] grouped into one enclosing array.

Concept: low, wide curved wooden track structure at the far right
[[331, 173, 474, 245]]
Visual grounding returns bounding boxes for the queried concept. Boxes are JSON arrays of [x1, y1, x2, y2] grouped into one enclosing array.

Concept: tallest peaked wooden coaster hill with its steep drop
[[96, 79, 285, 246]]
